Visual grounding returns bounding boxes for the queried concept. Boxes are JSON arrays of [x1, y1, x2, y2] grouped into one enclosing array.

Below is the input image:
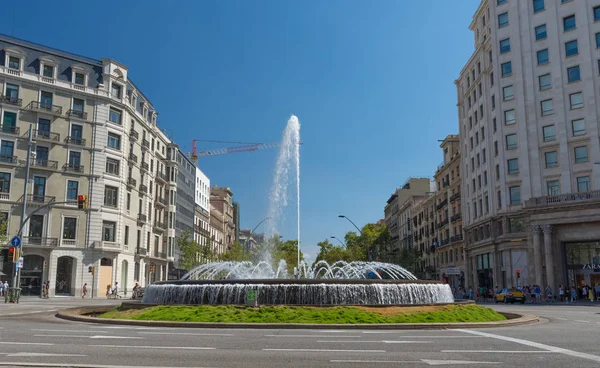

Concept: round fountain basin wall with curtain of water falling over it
[[142, 279, 454, 305]]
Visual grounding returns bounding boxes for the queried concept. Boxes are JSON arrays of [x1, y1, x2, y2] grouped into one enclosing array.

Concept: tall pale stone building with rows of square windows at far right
[[456, 0, 600, 289]]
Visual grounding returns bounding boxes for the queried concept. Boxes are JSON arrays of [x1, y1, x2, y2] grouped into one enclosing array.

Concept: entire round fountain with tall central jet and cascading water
[[142, 116, 454, 305]]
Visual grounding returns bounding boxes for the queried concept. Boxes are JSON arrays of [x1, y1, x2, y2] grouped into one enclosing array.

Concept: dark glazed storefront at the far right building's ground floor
[[565, 241, 600, 288]]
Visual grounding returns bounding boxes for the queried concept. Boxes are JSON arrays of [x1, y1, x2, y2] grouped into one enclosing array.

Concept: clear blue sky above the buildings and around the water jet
[[0, 0, 479, 264]]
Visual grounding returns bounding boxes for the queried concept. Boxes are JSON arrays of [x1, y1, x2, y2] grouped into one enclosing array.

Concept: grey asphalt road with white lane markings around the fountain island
[[0, 299, 600, 368]]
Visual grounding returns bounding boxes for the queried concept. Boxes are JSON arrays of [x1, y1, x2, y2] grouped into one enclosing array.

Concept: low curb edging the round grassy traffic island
[[56, 306, 540, 330]]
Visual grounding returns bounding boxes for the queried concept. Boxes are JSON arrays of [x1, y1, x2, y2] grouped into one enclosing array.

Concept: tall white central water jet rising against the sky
[[263, 115, 300, 265]]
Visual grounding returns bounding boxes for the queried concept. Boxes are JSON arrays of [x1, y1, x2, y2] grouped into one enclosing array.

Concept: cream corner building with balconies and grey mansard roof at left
[[0, 35, 172, 296]]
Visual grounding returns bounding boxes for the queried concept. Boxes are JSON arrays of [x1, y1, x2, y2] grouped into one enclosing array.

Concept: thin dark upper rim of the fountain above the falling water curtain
[[148, 279, 445, 287]]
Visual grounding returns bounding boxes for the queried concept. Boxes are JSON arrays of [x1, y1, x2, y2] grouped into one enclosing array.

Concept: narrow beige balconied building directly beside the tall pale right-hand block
[[434, 135, 466, 288]]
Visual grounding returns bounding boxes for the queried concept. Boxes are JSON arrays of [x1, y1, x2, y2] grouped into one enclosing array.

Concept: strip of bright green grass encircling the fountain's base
[[100, 305, 506, 324]]
